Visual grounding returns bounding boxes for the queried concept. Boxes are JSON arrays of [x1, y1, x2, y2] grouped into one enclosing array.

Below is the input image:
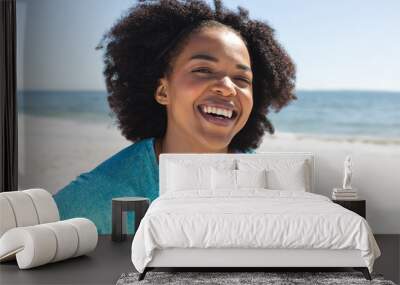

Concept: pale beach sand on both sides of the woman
[[18, 114, 400, 234]]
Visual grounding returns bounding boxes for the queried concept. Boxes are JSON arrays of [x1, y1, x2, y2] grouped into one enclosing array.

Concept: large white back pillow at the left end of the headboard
[[167, 163, 211, 191]]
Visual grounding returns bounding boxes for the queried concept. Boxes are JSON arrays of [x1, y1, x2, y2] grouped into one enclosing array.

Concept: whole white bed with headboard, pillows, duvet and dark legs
[[132, 153, 380, 280]]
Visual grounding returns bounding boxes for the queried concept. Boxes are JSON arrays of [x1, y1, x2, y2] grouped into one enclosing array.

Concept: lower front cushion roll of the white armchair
[[0, 218, 98, 269]]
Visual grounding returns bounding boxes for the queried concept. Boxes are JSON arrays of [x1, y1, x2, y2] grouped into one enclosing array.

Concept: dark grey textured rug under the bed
[[117, 271, 396, 285]]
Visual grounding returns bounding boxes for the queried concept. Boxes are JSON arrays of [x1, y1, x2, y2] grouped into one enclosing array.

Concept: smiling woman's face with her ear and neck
[[156, 27, 253, 152]]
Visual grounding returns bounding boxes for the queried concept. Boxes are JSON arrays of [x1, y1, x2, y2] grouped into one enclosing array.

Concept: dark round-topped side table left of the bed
[[111, 197, 150, 241]]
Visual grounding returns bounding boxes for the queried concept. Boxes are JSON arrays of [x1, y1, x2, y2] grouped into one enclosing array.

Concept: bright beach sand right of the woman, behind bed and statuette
[[259, 134, 400, 234]]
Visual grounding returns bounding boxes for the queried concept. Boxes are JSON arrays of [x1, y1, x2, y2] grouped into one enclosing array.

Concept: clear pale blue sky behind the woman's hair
[[17, 0, 400, 91]]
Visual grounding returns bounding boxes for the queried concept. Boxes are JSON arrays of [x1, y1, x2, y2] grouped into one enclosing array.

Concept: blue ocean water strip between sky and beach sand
[[18, 91, 400, 141]]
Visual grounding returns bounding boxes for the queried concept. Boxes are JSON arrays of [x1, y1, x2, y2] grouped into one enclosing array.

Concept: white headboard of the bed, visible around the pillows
[[159, 152, 315, 195]]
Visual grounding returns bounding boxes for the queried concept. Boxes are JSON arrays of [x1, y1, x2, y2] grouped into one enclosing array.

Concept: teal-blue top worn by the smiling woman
[[54, 138, 253, 234]]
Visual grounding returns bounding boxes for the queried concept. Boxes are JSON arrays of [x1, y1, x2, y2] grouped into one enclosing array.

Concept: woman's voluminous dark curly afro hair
[[97, 0, 297, 152]]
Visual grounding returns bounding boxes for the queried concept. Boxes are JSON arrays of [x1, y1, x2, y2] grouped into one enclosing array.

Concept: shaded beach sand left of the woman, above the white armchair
[[18, 114, 131, 193]]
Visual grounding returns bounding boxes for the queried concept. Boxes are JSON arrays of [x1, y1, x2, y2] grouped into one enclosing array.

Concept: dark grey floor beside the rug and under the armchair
[[0, 235, 400, 285]]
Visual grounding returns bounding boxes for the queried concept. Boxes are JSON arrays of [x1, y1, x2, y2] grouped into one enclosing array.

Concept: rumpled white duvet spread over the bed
[[132, 189, 380, 272]]
